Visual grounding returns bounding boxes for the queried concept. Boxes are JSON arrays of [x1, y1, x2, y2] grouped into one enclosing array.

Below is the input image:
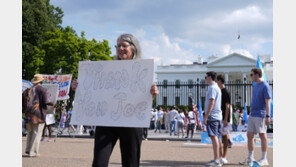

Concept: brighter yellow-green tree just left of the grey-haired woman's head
[[33, 26, 112, 78]]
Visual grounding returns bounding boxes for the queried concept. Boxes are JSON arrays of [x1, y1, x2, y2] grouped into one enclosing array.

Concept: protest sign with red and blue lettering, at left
[[42, 74, 72, 100]]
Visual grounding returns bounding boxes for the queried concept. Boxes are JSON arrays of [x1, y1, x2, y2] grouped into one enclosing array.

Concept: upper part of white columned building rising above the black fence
[[155, 53, 273, 82]]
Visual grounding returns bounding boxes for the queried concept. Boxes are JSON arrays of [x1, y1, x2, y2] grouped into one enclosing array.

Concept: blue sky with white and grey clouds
[[51, 0, 273, 65]]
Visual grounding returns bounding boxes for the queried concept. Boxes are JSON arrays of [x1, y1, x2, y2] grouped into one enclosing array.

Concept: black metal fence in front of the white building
[[155, 81, 273, 109]]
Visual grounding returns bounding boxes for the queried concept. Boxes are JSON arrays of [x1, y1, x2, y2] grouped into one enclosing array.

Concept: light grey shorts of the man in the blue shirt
[[248, 116, 267, 134]]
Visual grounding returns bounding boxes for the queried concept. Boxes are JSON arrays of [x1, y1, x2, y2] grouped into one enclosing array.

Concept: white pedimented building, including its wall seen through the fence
[[155, 53, 273, 105]]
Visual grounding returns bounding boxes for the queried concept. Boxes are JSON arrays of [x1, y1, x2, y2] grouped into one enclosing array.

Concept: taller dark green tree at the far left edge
[[22, 0, 64, 80]]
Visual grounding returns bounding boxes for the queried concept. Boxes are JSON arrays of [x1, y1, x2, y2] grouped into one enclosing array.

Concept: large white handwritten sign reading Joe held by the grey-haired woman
[[70, 59, 153, 127]]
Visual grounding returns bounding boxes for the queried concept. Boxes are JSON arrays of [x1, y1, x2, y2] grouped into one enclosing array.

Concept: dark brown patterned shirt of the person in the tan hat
[[22, 86, 44, 124]]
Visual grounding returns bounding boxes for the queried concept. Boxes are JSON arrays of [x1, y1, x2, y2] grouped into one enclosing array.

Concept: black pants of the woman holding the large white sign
[[92, 126, 143, 167]]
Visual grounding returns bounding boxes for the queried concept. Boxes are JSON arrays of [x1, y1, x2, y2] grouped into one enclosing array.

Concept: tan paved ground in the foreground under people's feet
[[22, 137, 273, 167]]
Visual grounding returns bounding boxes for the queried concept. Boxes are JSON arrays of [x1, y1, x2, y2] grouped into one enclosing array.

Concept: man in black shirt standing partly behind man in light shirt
[[217, 74, 231, 164]]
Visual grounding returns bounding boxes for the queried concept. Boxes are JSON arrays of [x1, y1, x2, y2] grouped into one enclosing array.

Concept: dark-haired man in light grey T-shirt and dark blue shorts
[[204, 71, 222, 166]]
